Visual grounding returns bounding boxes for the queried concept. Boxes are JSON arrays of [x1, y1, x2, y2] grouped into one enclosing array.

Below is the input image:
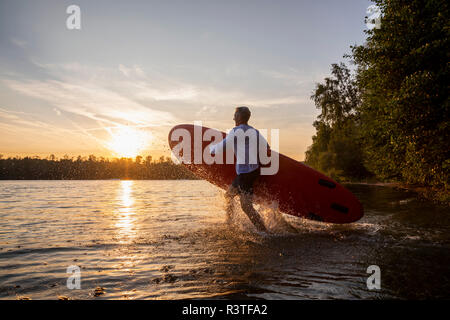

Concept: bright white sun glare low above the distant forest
[[106, 127, 151, 158]]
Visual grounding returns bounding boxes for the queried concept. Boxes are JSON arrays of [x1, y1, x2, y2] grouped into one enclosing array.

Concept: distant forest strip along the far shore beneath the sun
[[0, 155, 197, 180]]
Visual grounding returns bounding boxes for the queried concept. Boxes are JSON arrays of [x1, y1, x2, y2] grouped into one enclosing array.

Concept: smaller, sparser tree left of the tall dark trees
[[305, 63, 370, 180]]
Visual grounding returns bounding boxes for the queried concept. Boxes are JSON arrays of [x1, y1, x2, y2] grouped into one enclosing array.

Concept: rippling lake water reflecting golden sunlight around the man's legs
[[0, 181, 450, 299]]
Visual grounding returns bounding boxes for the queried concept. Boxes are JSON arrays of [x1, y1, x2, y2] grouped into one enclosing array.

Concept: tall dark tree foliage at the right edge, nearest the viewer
[[352, 0, 450, 188]]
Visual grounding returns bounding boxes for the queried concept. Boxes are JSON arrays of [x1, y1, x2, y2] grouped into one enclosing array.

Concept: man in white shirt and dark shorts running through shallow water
[[210, 107, 270, 232]]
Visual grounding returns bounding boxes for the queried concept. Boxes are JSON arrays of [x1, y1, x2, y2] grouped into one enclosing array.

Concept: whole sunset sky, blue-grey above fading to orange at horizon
[[0, 0, 371, 161]]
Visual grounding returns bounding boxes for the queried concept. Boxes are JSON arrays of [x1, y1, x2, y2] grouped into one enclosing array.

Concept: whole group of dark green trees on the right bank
[[305, 0, 450, 195]]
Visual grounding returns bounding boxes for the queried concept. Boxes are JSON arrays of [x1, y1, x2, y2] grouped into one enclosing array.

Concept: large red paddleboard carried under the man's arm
[[169, 124, 363, 223]]
